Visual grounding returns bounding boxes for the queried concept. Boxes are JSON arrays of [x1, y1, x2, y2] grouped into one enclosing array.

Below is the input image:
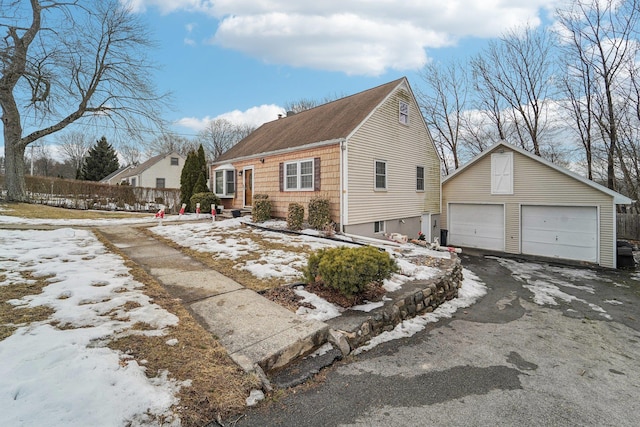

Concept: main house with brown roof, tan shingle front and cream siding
[[211, 78, 440, 238]]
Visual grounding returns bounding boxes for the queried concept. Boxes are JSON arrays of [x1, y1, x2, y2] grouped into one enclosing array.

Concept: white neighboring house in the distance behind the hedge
[[119, 152, 185, 188]]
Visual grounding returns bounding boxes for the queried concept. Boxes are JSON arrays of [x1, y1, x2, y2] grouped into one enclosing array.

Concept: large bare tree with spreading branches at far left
[[0, 0, 165, 200]]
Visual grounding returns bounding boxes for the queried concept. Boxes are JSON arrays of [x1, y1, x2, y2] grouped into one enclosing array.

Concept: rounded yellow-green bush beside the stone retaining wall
[[305, 246, 398, 297]]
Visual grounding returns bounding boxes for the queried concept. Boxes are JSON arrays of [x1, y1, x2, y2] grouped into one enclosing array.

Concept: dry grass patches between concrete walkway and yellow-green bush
[[144, 229, 312, 292]]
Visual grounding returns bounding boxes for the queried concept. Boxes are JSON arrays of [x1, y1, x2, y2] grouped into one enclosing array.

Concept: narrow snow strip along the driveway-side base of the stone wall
[[352, 269, 487, 355]]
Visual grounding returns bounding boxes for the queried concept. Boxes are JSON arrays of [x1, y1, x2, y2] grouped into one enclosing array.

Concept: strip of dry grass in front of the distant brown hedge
[[0, 202, 149, 219]]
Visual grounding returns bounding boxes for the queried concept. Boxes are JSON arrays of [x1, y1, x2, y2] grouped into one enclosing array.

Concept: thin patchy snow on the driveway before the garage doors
[[491, 257, 611, 320]]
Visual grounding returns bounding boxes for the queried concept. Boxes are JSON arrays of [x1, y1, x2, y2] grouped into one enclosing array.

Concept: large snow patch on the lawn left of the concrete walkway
[[0, 229, 188, 426]]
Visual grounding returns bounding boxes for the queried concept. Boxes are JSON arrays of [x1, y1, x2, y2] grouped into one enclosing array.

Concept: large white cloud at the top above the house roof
[[131, 0, 562, 75]]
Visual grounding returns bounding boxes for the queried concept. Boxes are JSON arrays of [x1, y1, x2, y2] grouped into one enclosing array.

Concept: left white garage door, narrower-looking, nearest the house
[[447, 203, 504, 251]]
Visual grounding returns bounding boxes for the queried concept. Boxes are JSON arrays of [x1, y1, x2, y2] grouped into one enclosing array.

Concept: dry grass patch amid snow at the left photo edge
[[0, 272, 54, 341]]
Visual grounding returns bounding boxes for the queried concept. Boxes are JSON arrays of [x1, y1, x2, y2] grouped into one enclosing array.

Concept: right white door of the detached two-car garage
[[521, 206, 598, 262]]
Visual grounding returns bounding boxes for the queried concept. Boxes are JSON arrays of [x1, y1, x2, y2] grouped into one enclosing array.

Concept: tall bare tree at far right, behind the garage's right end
[[558, 0, 640, 189]]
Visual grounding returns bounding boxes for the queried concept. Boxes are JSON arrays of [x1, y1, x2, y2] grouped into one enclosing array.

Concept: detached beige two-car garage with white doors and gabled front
[[441, 142, 632, 268]]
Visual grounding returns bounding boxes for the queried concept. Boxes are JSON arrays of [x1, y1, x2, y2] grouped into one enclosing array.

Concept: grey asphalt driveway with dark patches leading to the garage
[[232, 252, 640, 426]]
